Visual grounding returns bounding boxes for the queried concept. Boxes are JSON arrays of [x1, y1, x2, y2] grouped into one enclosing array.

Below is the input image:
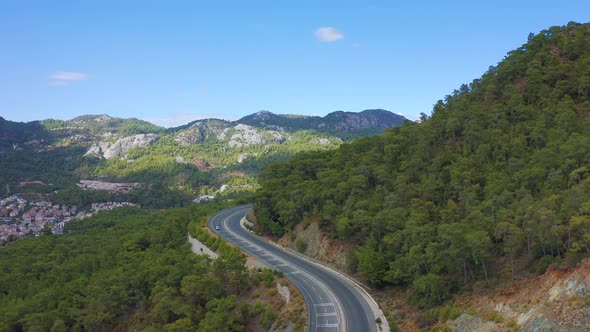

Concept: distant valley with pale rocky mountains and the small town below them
[[0, 110, 403, 243]]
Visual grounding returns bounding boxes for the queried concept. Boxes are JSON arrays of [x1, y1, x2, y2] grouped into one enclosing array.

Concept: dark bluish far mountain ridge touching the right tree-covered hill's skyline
[[236, 109, 407, 139]]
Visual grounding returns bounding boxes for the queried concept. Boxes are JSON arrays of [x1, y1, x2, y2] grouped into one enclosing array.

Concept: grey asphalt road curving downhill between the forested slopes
[[209, 205, 378, 332]]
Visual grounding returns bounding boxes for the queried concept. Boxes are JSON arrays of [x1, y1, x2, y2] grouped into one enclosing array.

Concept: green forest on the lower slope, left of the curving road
[[0, 205, 294, 332]]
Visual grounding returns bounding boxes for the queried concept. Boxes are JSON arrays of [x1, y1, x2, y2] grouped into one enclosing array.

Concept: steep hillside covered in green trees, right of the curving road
[[255, 23, 590, 303]]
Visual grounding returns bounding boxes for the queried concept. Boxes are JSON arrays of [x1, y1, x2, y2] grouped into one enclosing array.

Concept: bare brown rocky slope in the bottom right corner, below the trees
[[449, 259, 590, 332]]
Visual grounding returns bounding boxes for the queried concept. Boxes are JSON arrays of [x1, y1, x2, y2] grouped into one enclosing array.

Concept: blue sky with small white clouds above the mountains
[[0, 0, 590, 126]]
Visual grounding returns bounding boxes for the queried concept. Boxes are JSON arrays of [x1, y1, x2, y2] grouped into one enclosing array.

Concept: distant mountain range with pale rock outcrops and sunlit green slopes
[[0, 110, 405, 206]]
